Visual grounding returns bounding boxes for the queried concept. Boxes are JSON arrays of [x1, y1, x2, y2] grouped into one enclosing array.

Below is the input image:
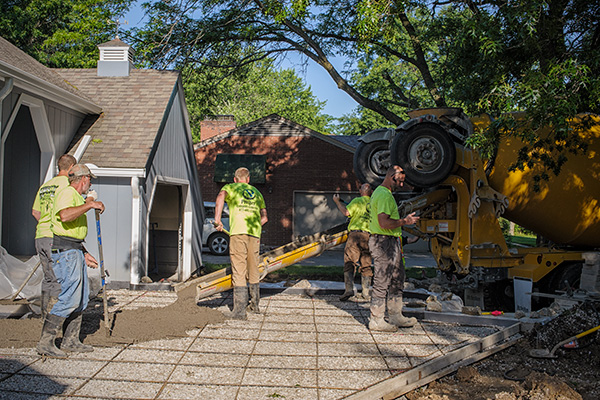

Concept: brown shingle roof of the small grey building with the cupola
[[55, 69, 179, 168]]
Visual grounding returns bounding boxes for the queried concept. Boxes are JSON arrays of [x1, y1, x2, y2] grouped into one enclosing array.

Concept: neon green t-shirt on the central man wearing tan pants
[[221, 182, 266, 238]]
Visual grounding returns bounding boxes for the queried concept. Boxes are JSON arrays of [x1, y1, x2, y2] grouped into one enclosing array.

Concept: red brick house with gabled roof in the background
[[194, 114, 359, 246]]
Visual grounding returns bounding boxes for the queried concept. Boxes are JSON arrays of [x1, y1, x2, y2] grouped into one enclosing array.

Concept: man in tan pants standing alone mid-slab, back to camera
[[215, 167, 268, 319]]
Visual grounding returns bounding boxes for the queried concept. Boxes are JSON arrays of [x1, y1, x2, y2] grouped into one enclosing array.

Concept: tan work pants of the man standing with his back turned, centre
[[229, 235, 260, 286]]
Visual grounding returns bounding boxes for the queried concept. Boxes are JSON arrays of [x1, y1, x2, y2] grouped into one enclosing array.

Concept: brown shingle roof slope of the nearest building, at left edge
[[0, 36, 90, 101]]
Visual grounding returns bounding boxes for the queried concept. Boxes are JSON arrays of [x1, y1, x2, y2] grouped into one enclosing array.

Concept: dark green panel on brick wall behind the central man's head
[[214, 154, 267, 184]]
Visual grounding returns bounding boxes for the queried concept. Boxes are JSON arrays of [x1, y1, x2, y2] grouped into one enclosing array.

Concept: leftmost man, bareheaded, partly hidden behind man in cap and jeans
[[31, 154, 77, 320]]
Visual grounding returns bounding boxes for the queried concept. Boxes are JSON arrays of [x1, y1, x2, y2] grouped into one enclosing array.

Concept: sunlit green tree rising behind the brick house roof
[[183, 59, 333, 141]]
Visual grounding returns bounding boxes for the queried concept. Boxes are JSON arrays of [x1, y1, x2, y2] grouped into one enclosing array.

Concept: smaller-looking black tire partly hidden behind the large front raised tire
[[352, 140, 391, 187]]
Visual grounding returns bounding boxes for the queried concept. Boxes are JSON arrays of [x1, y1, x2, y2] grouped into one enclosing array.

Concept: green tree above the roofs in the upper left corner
[[0, 0, 132, 68]]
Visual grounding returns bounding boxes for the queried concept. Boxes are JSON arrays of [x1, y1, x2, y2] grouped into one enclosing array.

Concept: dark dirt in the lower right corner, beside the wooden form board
[[406, 302, 600, 400]]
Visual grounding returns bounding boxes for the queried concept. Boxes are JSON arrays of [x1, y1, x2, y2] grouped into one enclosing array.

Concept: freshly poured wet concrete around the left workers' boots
[[0, 287, 225, 347]]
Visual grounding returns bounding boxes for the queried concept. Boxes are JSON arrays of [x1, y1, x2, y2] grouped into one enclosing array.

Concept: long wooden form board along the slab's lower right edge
[[345, 322, 521, 400]]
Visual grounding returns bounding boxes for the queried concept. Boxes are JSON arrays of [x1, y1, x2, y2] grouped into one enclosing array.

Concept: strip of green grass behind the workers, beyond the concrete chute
[[204, 264, 437, 282]]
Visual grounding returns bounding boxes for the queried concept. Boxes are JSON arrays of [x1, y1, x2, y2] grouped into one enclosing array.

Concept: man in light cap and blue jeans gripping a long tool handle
[[37, 164, 104, 358]]
